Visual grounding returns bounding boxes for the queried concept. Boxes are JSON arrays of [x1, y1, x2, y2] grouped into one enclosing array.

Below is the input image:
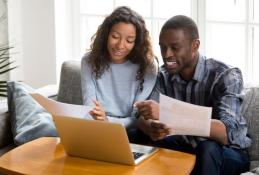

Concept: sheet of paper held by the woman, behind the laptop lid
[[30, 93, 92, 119]]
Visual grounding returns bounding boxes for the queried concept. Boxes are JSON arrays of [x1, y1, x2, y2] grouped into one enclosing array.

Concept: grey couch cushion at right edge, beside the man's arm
[[242, 86, 259, 160]]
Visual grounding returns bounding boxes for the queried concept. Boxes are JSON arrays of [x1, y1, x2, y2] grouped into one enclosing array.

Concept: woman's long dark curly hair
[[89, 6, 154, 91]]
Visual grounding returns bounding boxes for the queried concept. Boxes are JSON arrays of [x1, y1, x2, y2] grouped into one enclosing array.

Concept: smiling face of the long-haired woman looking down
[[107, 22, 136, 64]]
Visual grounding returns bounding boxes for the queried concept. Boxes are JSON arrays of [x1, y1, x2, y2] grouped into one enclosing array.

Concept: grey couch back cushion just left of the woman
[[57, 60, 83, 104]]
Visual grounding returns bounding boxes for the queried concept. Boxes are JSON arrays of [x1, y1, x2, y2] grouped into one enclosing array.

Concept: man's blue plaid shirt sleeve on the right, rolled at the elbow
[[212, 68, 251, 148]]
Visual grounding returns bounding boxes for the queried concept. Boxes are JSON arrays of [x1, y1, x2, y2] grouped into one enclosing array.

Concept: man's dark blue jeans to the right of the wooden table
[[192, 140, 250, 175]]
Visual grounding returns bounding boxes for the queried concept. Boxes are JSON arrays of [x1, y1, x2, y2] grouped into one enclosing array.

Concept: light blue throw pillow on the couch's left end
[[7, 82, 57, 145]]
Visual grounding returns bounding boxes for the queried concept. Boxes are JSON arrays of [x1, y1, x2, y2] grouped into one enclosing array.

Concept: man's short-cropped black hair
[[160, 15, 199, 41]]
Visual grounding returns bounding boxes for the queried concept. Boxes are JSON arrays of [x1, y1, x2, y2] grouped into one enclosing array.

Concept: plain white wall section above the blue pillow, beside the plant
[[8, 0, 57, 88]]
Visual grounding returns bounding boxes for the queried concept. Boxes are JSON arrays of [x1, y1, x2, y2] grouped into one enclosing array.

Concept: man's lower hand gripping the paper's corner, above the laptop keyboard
[[138, 116, 170, 141]]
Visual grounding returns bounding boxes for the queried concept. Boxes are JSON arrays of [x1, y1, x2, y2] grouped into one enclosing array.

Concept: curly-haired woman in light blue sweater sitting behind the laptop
[[81, 6, 157, 129]]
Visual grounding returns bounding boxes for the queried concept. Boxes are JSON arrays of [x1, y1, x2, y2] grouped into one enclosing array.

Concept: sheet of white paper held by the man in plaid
[[159, 94, 212, 137]]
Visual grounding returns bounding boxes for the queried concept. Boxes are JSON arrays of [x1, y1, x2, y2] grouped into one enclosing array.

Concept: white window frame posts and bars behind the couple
[[70, 0, 259, 83]]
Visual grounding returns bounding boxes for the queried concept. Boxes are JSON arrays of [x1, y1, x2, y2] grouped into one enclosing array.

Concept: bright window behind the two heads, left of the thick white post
[[77, 0, 191, 63]]
